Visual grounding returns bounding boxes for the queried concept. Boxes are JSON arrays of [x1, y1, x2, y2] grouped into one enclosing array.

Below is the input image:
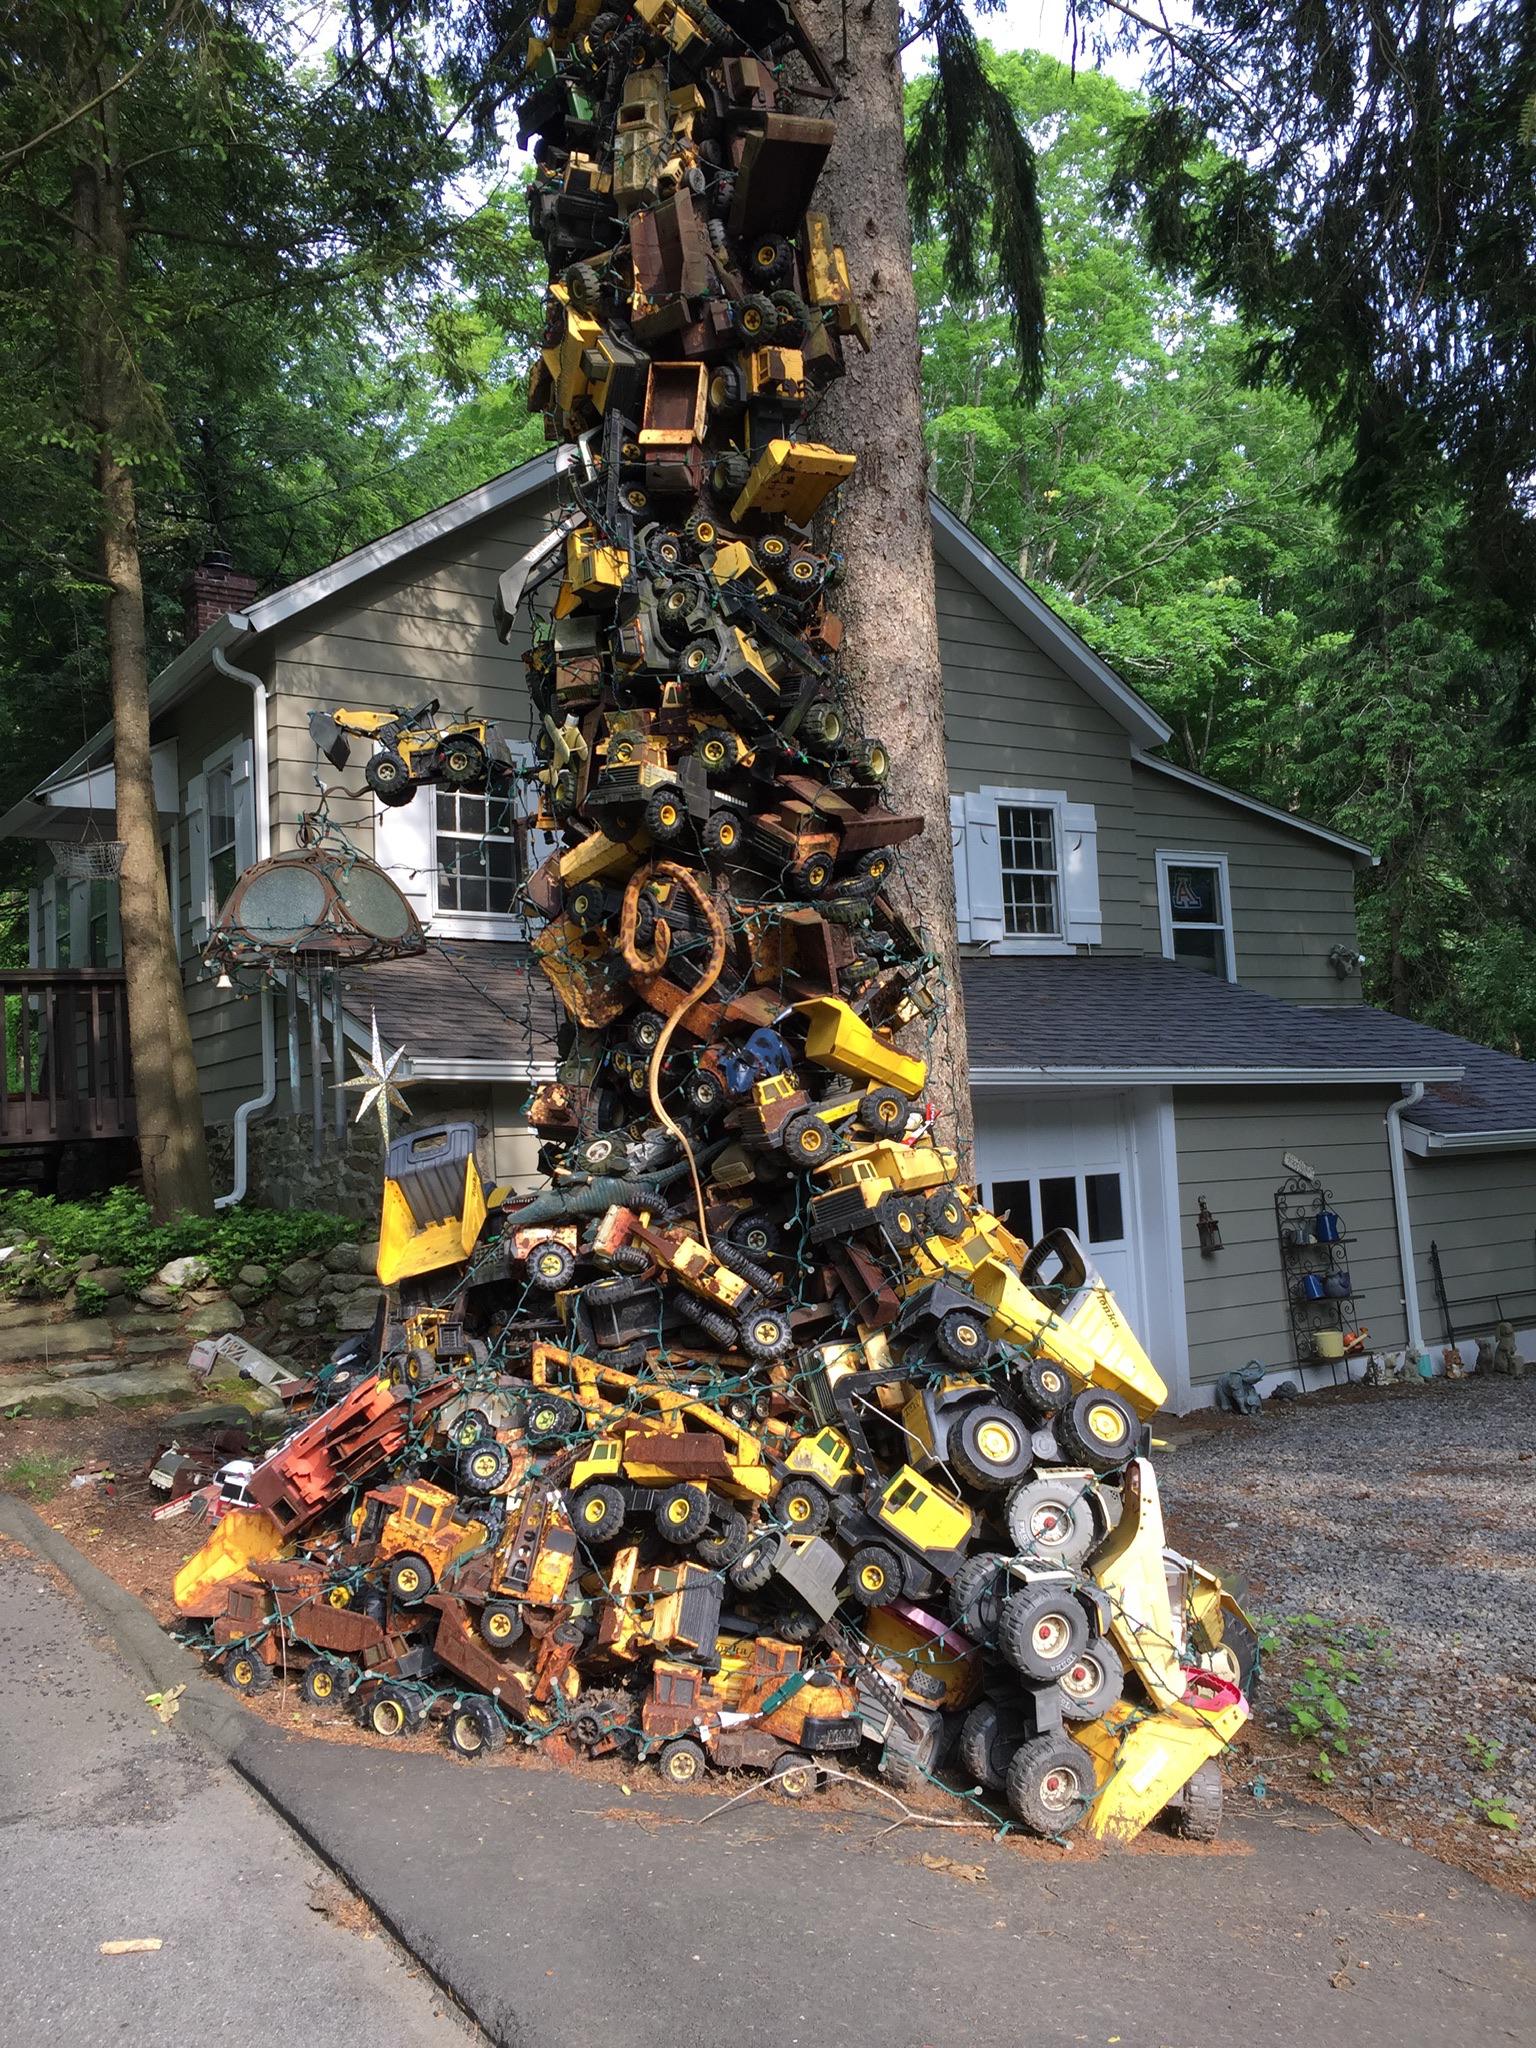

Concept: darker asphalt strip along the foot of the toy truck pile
[[0, 1501, 1536, 2048]]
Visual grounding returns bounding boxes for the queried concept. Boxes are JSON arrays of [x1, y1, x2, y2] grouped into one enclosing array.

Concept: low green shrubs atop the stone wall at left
[[0, 1188, 362, 1288]]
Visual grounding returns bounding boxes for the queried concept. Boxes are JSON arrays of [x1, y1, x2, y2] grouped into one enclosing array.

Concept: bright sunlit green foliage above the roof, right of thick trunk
[[911, 53, 1329, 780]]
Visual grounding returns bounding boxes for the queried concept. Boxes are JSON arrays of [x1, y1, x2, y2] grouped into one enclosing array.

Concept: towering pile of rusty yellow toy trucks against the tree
[[176, 0, 1253, 1839]]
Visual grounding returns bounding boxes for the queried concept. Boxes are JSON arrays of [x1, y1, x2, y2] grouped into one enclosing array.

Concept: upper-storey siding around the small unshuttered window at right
[[1130, 764, 1362, 1004]]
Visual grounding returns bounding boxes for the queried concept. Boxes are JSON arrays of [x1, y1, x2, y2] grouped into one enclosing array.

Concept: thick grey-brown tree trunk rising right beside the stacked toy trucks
[[805, 0, 973, 1157]]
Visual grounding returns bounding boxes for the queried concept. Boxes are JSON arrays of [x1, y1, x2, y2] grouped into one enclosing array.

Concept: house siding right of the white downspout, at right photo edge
[[1407, 1151, 1536, 1364]]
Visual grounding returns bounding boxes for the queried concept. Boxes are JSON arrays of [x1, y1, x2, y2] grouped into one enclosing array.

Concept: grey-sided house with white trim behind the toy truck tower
[[0, 459, 1536, 1409]]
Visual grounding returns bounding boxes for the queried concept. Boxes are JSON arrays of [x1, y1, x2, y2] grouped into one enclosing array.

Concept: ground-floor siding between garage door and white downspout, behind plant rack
[[1176, 1087, 1407, 1391]]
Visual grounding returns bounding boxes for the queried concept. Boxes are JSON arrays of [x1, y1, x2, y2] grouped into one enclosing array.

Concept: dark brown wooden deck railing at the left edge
[[0, 967, 137, 1145]]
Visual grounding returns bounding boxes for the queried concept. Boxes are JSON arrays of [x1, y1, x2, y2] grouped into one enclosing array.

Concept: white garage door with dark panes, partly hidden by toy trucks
[[975, 1094, 1143, 1329]]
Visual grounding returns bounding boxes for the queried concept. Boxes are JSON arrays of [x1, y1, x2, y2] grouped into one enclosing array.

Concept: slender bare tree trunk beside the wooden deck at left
[[74, 83, 213, 1221]]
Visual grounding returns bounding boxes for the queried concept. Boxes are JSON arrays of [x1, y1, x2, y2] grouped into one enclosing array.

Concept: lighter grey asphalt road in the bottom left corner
[[0, 1544, 479, 2048]]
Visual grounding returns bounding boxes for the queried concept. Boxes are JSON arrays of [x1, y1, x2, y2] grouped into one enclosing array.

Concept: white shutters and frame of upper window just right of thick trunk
[[950, 784, 1104, 956]]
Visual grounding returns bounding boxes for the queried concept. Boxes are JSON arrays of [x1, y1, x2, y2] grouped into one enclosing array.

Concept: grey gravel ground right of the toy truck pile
[[1159, 1378, 1536, 1894]]
